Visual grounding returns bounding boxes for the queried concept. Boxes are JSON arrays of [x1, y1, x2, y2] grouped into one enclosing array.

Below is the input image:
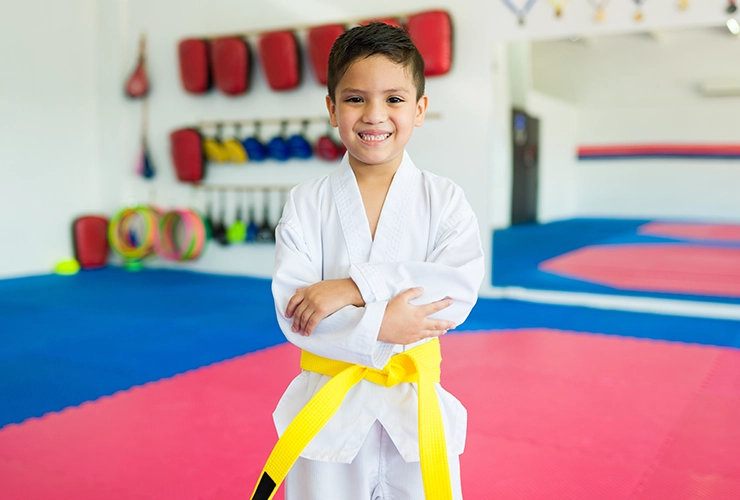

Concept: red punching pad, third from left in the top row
[[259, 31, 301, 90]]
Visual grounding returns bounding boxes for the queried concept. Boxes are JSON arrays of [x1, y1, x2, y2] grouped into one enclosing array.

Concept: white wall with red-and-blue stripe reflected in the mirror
[[533, 27, 740, 221]]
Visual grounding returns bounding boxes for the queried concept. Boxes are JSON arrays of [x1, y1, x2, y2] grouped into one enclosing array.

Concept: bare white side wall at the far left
[[0, 0, 101, 276]]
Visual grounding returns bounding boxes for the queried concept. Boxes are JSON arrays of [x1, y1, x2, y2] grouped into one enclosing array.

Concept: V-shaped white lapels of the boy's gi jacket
[[331, 151, 421, 264]]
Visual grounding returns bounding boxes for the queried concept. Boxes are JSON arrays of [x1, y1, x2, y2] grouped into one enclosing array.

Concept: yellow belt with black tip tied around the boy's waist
[[252, 339, 452, 500]]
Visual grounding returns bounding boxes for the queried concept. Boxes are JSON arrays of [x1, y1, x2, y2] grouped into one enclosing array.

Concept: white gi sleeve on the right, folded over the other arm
[[349, 188, 485, 325]]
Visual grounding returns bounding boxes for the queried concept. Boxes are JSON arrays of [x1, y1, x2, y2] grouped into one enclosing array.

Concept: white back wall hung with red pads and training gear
[[95, 0, 500, 276]]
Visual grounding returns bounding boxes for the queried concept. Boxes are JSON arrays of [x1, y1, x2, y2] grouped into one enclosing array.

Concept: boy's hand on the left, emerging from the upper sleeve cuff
[[285, 278, 365, 336]]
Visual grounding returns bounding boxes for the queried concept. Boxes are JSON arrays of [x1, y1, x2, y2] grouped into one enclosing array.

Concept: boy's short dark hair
[[326, 22, 424, 101]]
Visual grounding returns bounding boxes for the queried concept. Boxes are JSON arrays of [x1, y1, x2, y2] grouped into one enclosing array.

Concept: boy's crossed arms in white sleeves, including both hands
[[272, 195, 484, 368]]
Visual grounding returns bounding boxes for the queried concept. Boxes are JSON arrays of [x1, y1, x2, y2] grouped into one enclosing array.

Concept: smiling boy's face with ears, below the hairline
[[326, 54, 428, 171]]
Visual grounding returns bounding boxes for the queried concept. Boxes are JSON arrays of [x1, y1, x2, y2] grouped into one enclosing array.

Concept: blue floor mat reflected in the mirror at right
[[491, 219, 740, 304]]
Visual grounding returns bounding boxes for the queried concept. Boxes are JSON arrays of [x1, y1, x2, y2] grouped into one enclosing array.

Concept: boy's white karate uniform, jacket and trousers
[[272, 152, 484, 500]]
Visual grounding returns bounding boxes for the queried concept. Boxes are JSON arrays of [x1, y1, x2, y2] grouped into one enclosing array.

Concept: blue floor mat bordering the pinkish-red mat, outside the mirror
[[0, 268, 740, 427]]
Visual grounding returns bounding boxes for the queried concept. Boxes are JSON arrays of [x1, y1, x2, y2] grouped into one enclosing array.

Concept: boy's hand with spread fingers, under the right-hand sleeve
[[378, 287, 455, 345]]
